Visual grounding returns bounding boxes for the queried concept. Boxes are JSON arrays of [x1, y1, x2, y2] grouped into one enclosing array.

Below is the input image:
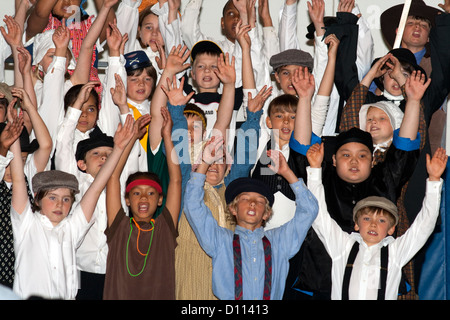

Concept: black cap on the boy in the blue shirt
[[225, 177, 275, 206]]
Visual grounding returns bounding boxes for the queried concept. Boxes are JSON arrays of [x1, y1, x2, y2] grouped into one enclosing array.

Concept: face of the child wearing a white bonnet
[[365, 107, 394, 144]]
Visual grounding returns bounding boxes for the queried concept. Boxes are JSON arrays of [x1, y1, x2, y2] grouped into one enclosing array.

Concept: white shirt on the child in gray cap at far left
[[11, 202, 94, 299]]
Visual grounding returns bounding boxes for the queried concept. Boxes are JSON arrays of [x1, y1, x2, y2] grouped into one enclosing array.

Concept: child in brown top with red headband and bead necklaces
[[103, 108, 181, 300]]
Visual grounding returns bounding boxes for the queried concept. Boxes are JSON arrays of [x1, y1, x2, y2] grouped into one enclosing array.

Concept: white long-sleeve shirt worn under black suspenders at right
[[307, 167, 443, 300]]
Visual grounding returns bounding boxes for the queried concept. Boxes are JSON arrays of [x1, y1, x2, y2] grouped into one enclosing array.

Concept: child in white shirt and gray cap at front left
[[11, 114, 133, 299]]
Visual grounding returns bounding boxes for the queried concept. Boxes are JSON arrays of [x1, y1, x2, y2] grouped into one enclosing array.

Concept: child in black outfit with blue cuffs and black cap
[[287, 68, 420, 299]]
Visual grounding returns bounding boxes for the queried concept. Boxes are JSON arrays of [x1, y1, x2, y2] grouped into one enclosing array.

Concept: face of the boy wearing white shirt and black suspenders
[[355, 212, 395, 247]]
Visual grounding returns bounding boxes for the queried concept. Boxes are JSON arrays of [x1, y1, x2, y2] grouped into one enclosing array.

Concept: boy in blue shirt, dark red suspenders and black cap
[[184, 137, 317, 300]]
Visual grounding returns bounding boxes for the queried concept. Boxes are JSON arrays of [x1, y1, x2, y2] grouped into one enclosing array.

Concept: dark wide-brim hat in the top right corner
[[380, 0, 443, 48]]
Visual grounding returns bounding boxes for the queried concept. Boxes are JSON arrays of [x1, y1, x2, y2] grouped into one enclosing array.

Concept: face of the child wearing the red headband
[[125, 185, 163, 222]]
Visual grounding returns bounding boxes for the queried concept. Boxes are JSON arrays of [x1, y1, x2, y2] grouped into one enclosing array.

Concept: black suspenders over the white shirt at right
[[342, 242, 389, 300]]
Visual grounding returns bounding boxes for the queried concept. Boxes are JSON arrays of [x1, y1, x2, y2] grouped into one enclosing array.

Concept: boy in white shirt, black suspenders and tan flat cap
[[307, 144, 447, 300]]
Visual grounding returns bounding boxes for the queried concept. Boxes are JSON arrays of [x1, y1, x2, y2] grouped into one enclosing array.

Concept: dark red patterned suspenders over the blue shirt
[[233, 234, 272, 300]]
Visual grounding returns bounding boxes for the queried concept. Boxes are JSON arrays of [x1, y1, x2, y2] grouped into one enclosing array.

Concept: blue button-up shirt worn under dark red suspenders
[[184, 172, 318, 300]]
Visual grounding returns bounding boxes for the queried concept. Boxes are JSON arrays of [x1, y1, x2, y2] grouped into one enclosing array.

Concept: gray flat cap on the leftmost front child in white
[[31, 170, 80, 193]]
